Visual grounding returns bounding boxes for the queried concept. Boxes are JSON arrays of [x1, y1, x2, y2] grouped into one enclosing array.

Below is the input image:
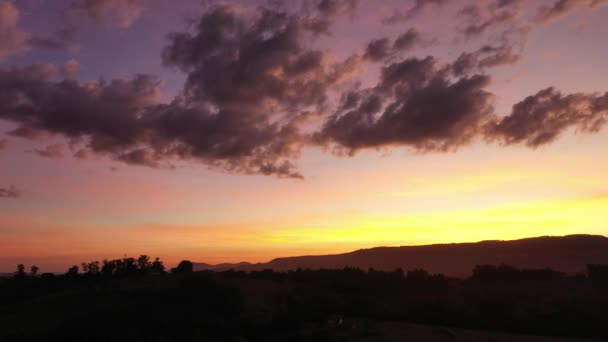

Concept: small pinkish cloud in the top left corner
[[0, 0, 30, 60]]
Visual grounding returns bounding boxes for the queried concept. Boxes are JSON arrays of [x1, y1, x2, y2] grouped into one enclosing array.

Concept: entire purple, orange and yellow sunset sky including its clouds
[[0, 0, 608, 272]]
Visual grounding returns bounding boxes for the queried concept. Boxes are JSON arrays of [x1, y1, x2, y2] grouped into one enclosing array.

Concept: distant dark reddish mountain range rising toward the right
[[194, 235, 608, 277]]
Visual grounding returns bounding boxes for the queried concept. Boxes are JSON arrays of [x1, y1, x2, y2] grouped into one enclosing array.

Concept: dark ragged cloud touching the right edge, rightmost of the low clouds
[[487, 87, 608, 147]]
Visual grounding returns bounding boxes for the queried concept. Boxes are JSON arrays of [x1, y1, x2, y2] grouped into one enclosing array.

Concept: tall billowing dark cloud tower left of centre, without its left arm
[[158, 2, 357, 177]]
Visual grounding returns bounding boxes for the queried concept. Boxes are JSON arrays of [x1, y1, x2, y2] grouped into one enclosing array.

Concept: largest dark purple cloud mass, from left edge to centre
[[0, 5, 358, 177]]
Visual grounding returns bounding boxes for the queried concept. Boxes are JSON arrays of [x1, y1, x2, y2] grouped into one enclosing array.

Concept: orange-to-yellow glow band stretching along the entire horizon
[[0, 195, 608, 265]]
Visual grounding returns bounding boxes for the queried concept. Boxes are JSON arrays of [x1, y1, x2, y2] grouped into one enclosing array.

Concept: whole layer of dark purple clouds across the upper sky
[[0, 0, 608, 178]]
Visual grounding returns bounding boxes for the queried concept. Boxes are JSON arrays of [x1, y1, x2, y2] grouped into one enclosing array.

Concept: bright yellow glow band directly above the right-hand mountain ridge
[[256, 196, 608, 251]]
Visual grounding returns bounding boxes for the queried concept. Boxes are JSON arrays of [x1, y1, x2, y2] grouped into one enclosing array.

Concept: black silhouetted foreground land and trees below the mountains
[[0, 236, 608, 342]]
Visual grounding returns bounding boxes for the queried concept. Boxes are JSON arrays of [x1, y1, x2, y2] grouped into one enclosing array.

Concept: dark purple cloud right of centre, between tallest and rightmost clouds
[[316, 57, 493, 154]]
